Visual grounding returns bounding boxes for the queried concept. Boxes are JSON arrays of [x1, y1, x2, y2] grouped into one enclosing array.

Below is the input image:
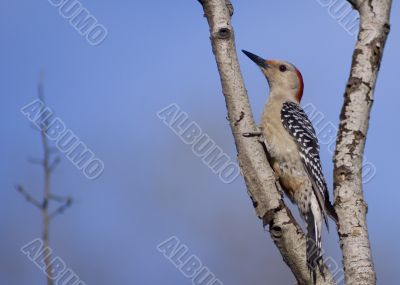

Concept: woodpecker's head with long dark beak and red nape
[[242, 50, 304, 103]]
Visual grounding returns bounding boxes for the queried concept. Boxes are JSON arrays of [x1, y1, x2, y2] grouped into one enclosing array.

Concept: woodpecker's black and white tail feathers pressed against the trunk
[[306, 211, 323, 284]]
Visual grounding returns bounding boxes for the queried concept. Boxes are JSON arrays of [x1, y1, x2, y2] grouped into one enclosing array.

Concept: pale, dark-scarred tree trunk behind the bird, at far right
[[334, 0, 392, 285]]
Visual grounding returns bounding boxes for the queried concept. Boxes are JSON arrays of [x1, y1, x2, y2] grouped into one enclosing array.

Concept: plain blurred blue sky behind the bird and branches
[[0, 0, 400, 285]]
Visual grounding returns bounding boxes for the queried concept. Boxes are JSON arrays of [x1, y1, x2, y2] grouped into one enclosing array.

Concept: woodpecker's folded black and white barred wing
[[281, 102, 332, 227]]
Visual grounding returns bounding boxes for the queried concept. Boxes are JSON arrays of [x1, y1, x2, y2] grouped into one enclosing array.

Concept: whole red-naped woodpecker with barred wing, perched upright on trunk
[[242, 50, 338, 284]]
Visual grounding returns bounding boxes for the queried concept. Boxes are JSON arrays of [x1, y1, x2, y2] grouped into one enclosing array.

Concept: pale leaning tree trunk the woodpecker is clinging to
[[200, 0, 334, 285]]
